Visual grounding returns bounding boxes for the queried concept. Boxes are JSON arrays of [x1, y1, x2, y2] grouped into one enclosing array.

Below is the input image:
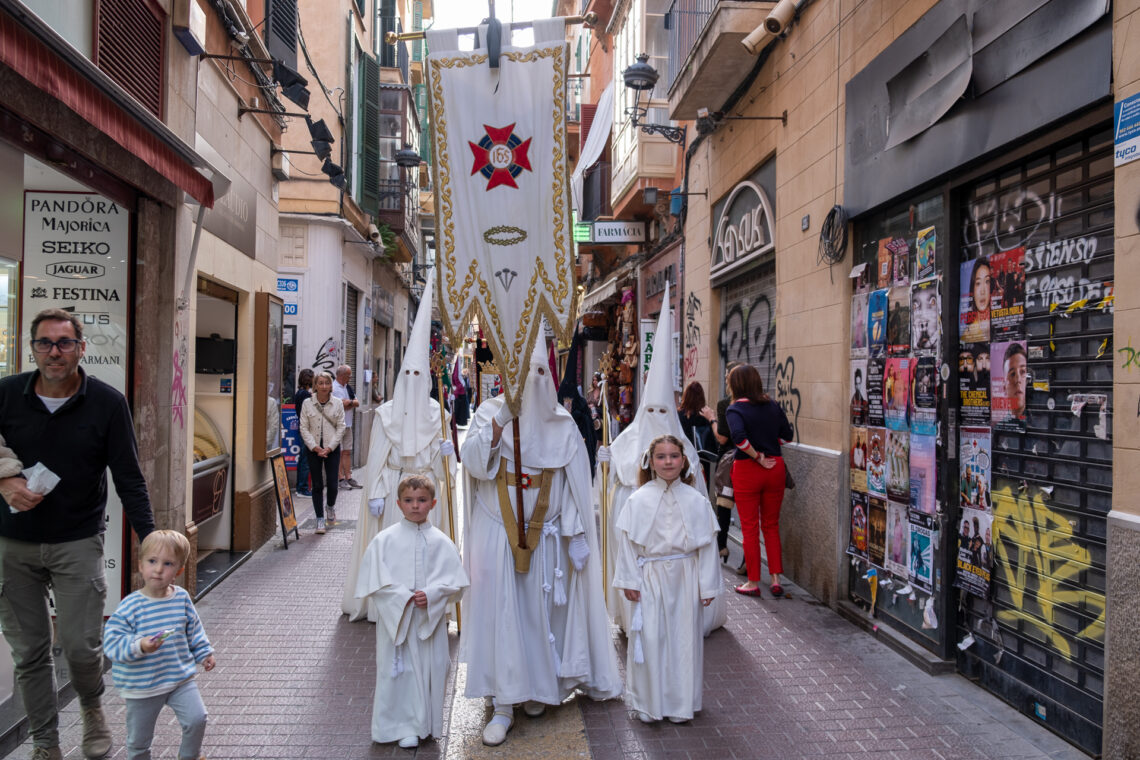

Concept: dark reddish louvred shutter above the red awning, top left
[[95, 0, 166, 119]]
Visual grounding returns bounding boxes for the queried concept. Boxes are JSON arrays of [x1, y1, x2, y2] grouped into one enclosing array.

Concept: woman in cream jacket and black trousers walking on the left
[[300, 373, 345, 533]]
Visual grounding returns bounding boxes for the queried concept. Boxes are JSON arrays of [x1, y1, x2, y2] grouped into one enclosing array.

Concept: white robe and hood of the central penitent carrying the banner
[[459, 337, 621, 704]]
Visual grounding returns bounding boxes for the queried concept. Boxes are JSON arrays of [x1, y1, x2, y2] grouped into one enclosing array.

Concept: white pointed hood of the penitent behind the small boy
[[376, 269, 441, 457]]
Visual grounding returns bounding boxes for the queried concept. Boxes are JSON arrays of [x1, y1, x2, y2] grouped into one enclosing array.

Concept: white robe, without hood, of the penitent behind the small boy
[[341, 407, 455, 622]]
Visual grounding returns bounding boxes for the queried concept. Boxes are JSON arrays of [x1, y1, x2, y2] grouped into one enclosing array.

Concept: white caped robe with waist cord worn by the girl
[[613, 479, 723, 720]]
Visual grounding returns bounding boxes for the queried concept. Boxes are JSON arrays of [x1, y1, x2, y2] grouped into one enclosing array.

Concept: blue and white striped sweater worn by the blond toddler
[[103, 586, 213, 698]]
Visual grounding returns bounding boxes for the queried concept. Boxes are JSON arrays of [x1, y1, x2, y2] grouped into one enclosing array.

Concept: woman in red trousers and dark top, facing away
[[726, 365, 793, 597]]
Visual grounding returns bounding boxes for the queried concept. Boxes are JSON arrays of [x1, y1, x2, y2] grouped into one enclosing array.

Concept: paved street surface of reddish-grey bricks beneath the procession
[[10, 464, 1088, 760]]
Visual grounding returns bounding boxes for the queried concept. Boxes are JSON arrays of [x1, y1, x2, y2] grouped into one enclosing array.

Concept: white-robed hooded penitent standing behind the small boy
[[341, 273, 455, 622]]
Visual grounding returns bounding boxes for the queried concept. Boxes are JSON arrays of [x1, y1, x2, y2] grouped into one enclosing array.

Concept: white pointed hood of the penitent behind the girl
[[610, 283, 701, 488]]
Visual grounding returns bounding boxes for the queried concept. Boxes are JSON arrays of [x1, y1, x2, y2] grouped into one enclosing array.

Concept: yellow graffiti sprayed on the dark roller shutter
[[992, 485, 1105, 659]]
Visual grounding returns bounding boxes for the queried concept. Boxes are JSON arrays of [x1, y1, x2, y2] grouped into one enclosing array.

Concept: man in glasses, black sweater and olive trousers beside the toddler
[[0, 309, 154, 760]]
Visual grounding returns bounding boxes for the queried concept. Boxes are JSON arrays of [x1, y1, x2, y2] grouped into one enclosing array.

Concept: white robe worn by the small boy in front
[[356, 518, 467, 742]]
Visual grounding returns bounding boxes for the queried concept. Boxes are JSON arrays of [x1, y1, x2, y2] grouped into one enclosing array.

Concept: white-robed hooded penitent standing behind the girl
[[604, 283, 728, 636]]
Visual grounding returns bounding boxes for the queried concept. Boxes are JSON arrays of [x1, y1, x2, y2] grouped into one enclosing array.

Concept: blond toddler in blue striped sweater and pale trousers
[[103, 530, 215, 760]]
